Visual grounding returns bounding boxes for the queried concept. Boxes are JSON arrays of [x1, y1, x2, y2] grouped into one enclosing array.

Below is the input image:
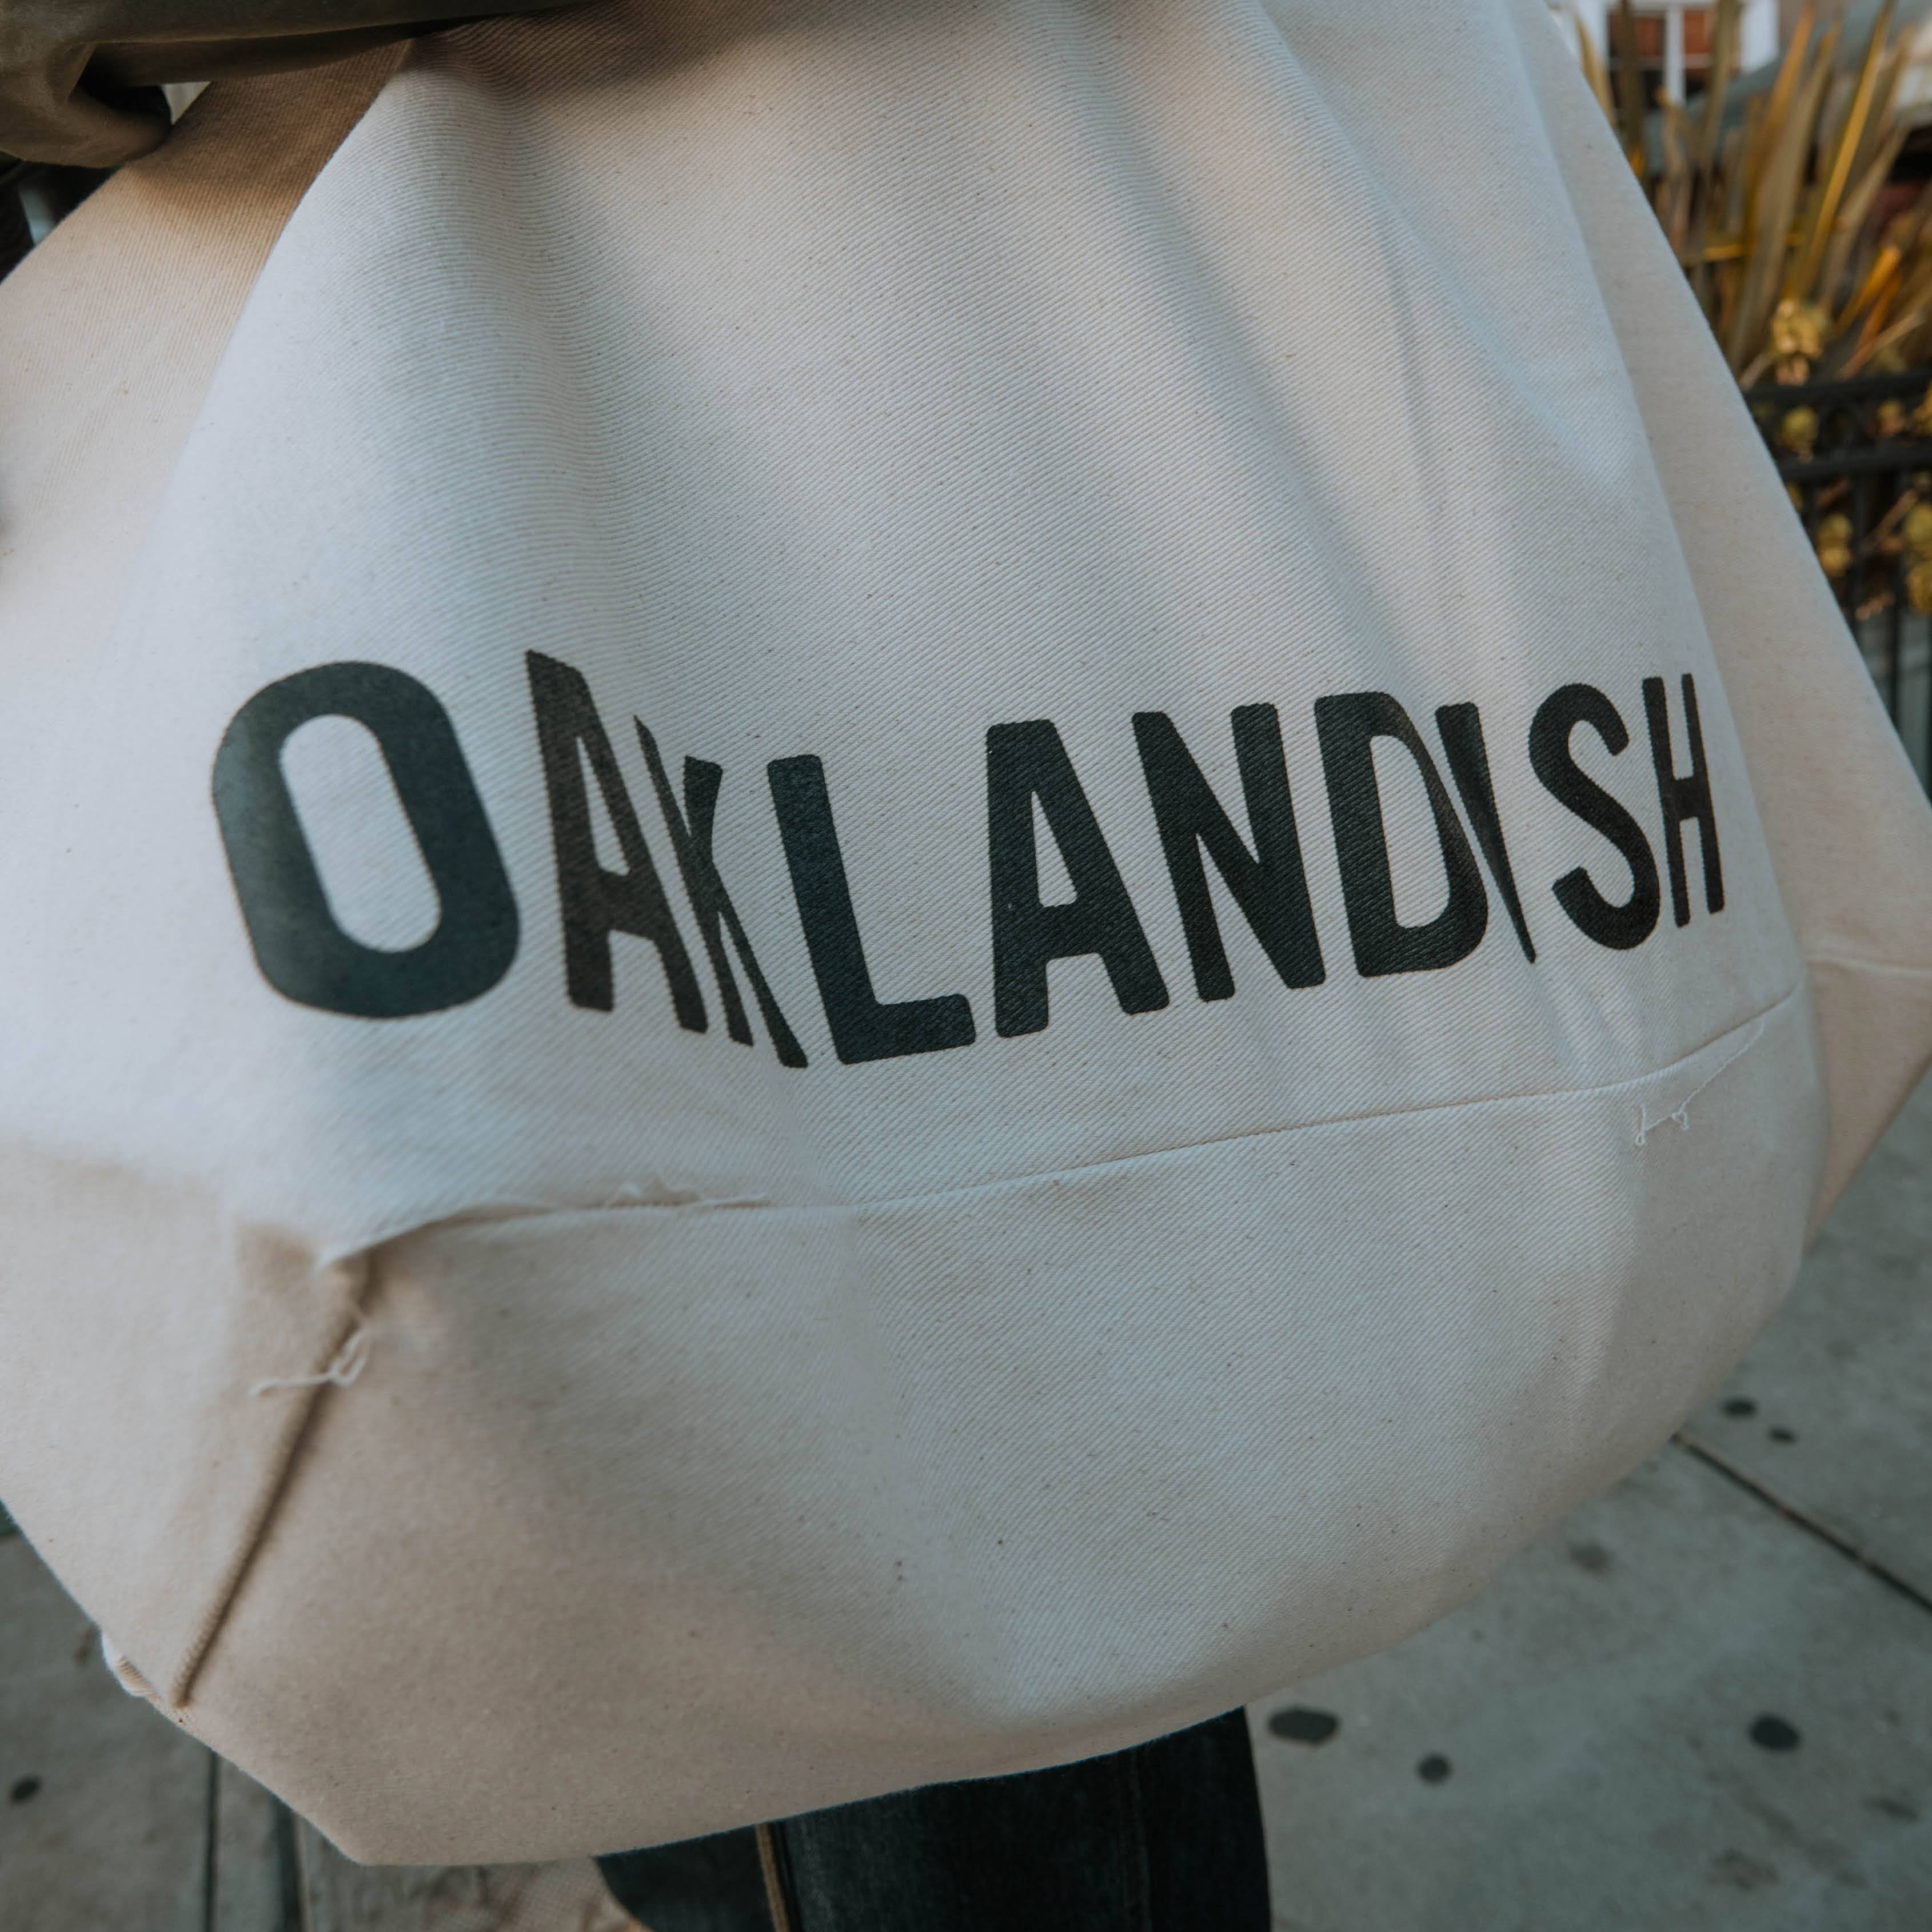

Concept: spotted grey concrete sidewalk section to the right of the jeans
[[1254, 1084, 1932, 1932]]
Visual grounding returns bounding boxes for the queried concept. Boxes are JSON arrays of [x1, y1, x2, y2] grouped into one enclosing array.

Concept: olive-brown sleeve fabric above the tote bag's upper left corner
[[0, 0, 566, 168]]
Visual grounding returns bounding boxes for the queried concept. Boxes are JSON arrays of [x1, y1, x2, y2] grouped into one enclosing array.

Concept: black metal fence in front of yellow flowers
[[1747, 369, 1932, 784]]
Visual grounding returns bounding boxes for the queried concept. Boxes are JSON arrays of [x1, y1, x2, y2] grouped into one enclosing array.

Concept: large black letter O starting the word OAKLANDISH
[[214, 662, 518, 1020]]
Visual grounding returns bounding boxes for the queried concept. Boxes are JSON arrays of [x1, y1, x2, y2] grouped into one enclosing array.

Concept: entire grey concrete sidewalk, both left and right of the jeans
[[0, 1084, 1932, 1932]]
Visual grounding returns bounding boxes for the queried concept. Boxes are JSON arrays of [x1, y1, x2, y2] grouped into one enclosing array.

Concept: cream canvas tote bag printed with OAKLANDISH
[[0, 0, 1932, 1862]]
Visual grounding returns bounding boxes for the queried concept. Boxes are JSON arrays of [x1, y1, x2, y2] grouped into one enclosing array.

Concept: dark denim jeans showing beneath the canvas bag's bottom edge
[[601, 1710, 1270, 1932]]
